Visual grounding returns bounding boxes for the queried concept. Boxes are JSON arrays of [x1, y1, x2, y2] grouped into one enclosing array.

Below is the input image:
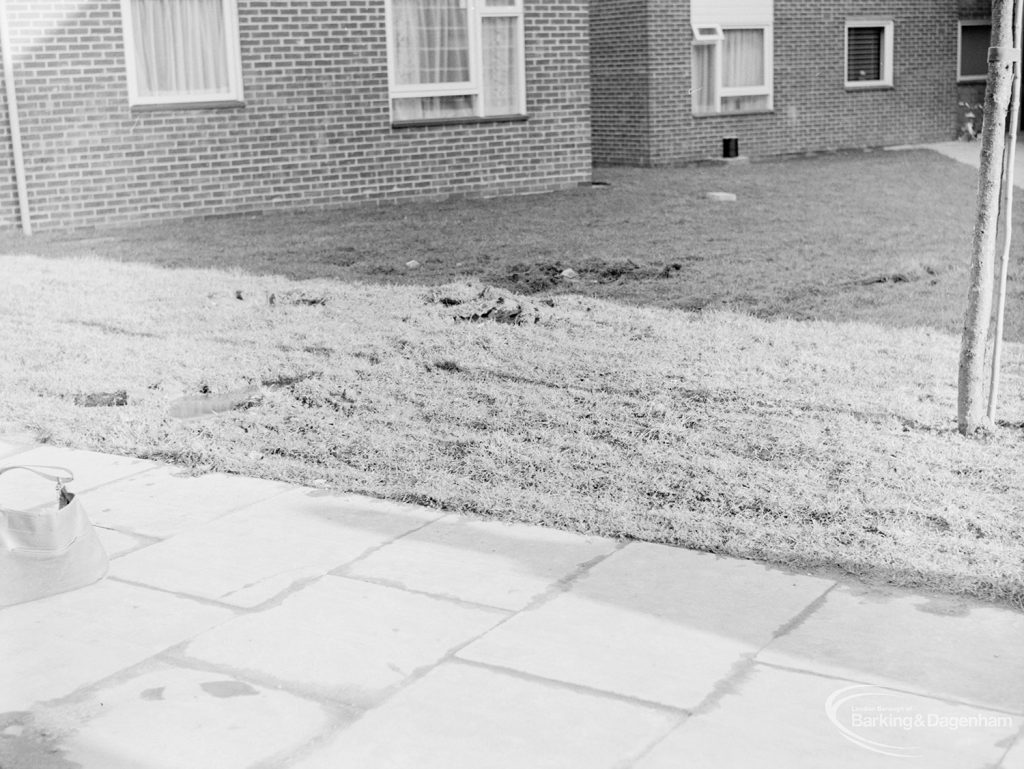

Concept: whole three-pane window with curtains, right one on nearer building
[[388, 0, 526, 123]]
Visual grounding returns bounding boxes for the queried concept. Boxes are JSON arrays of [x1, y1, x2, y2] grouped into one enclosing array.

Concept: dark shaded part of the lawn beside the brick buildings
[[0, 151, 1024, 341]]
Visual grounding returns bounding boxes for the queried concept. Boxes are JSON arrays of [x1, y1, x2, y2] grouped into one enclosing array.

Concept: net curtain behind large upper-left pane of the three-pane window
[[391, 0, 469, 85]]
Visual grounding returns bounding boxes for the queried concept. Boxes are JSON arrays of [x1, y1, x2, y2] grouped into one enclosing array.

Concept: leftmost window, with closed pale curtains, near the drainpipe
[[121, 0, 242, 105]]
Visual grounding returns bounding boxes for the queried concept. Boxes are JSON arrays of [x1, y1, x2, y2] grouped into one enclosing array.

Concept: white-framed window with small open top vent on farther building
[[691, 25, 772, 115]]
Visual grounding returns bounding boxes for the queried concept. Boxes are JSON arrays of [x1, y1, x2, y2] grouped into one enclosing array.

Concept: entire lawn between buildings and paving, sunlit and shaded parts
[[0, 152, 1024, 605]]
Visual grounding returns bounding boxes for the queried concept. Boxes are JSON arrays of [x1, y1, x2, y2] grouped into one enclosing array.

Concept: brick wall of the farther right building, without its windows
[[592, 0, 957, 165]]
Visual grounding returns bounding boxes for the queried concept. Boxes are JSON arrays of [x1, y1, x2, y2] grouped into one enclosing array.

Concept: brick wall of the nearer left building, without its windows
[[0, 0, 591, 229]]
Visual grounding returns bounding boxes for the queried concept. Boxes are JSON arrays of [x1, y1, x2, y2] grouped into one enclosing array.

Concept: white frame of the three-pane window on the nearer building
[[384, 0, 526, 123]]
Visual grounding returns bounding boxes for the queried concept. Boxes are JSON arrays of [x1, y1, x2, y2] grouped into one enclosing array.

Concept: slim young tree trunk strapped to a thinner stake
[[956, 0, 1015, 435]]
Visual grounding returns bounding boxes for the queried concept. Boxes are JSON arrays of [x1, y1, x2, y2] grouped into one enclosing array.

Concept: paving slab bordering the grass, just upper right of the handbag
[[82, 466, 294, 539]]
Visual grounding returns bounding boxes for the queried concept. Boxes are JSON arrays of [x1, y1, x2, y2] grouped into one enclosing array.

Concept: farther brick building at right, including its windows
[[591, 0, 990, 166]]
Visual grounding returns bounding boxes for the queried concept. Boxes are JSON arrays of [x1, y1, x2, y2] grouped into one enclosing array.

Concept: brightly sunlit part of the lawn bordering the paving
[[0, 255, 1024, 604]]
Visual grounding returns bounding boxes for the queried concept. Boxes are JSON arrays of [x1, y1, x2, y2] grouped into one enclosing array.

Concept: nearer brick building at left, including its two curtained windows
[[0, 0, 591, 230]]
